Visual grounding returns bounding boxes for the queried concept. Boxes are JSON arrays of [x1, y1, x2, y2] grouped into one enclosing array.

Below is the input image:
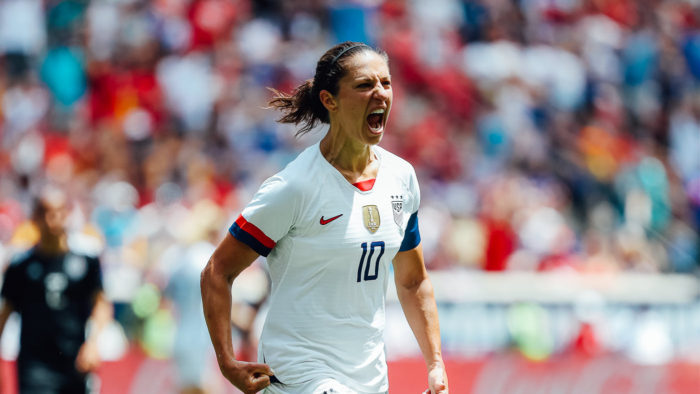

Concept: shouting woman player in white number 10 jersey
[[201, 42, 448, 394]]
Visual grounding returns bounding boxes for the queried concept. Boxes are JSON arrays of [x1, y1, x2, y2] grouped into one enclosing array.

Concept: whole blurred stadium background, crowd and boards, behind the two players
[[0, 0, 700, 393]]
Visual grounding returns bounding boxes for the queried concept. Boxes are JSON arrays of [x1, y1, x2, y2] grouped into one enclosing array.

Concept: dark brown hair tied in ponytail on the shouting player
[[268, 41, 388, 136]]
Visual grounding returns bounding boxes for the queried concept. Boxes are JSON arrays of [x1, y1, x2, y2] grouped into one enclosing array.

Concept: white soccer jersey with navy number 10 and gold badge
[[230, 143, 420, 393]]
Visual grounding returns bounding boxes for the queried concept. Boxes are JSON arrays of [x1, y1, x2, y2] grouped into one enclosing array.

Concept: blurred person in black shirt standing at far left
[[0, 189, 111, 394]]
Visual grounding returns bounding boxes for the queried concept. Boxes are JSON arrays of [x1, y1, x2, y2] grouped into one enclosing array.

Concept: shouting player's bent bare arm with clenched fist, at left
[[200, 233, 272, 394]]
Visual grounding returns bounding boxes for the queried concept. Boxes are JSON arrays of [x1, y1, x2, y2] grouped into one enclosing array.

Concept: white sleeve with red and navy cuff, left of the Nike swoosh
[[229, 176, 297, 256]]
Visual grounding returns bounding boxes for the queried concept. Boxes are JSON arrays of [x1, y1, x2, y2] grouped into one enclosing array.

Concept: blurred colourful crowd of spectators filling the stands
[[0, 0, 700, 370]]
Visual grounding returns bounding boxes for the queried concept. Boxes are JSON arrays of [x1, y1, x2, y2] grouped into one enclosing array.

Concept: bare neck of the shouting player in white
[[320, 127, 377, 183]]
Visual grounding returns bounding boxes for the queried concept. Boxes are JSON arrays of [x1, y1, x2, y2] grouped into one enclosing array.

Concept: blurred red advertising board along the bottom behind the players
[[2, 349, 700, 394]]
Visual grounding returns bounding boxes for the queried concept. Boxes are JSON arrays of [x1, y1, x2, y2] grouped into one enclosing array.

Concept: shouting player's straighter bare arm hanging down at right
[[394, 245, 448, 394]]
